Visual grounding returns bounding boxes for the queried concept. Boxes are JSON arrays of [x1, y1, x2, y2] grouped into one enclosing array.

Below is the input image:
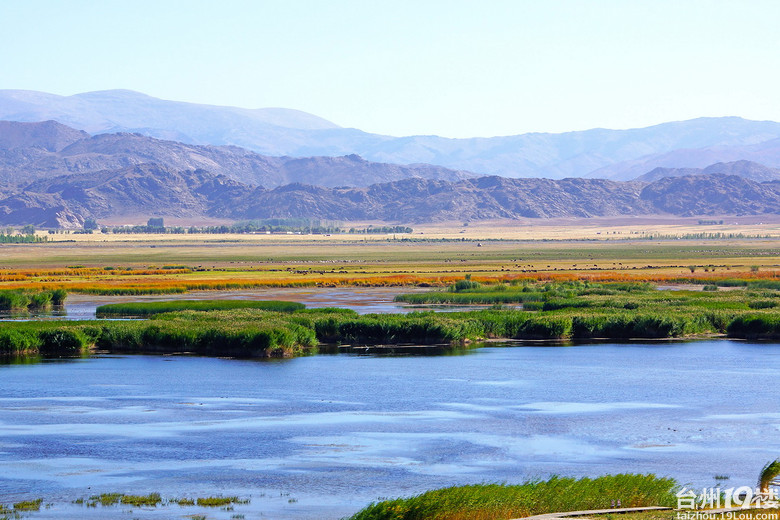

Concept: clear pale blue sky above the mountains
[[0, 0, 780, 137]]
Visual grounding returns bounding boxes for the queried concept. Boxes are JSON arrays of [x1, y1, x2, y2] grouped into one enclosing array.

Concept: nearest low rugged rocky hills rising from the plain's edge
[[0, 164, 780, 227]]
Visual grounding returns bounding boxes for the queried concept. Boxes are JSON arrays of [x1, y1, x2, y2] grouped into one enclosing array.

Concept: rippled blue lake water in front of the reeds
[[0, 341, 780, 519]]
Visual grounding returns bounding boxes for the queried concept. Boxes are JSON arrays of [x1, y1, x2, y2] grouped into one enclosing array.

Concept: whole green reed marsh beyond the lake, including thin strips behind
[[0, 281, 780, 358]]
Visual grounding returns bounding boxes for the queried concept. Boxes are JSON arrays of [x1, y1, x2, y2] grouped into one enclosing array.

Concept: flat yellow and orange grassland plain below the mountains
[[0, 219, 780, 292]]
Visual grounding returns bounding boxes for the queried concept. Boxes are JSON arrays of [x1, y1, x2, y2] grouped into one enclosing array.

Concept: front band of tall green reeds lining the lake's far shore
[[0, 309, 760, 358]]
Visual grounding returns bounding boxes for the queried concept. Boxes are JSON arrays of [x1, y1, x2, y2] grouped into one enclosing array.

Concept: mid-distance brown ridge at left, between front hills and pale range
[[0, 121, 474, 188]]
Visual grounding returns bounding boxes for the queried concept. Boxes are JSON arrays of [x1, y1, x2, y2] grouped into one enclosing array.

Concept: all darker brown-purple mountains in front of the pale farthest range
[[0, 121, 780, 227]]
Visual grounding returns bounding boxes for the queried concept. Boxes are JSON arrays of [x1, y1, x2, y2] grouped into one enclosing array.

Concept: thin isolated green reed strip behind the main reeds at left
[[96, 300, 306, 317]]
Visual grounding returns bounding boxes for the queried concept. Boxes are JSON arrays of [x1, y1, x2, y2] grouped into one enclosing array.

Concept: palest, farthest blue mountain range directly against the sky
[[0, 90, 780, 180]]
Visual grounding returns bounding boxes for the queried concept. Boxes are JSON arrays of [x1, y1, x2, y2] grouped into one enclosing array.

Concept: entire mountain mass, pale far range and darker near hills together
[[0, 91, 780, 228]]
